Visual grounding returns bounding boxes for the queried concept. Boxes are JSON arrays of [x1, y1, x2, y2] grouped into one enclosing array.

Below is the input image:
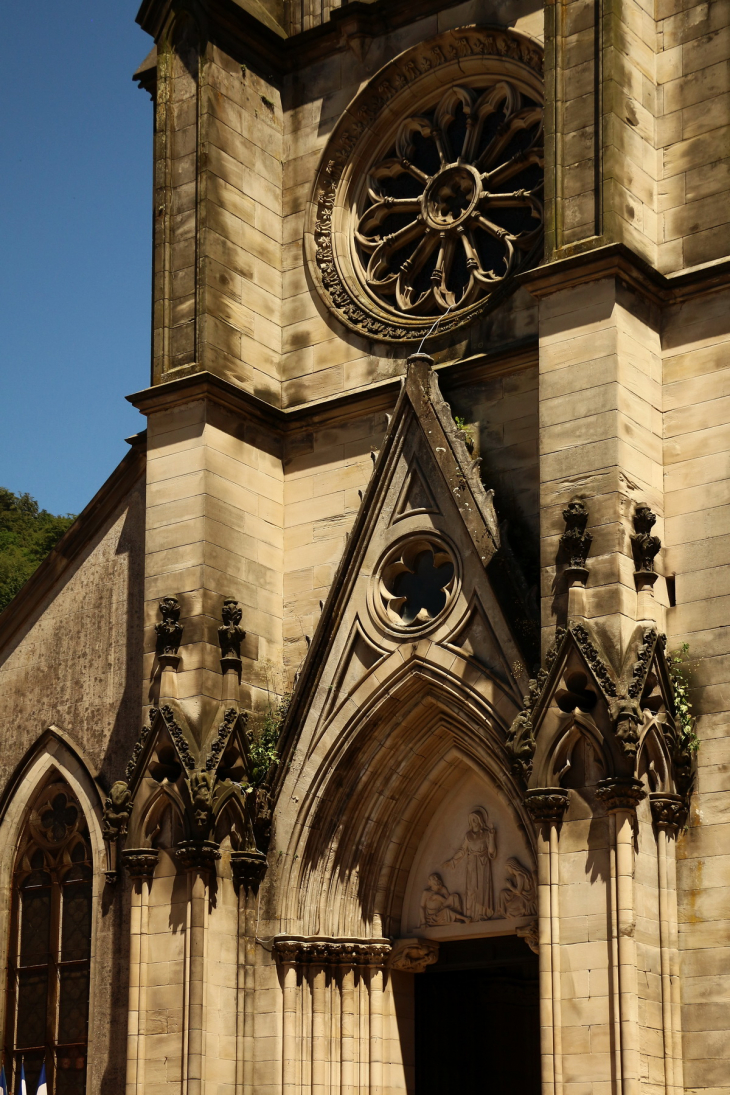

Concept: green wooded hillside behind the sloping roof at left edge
[[0, 487, 76, 612]]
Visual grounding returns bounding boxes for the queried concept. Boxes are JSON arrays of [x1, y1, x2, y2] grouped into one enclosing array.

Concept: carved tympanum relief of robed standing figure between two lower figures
[[403, 776, 537, 938]]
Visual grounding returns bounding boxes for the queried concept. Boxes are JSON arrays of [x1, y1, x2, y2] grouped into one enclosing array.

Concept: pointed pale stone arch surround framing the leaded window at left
[[0, 726, 104, 1095]]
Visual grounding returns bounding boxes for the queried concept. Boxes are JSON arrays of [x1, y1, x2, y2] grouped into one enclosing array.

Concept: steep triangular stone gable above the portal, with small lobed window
[[279, 355, 524, 772]]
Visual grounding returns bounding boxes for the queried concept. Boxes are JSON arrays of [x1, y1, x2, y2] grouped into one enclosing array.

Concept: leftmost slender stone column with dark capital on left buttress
[[121, 848, 158, 1095]]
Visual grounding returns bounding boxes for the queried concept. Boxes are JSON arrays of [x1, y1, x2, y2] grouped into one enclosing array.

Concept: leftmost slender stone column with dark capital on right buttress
[[525, 787, 568, 1095]]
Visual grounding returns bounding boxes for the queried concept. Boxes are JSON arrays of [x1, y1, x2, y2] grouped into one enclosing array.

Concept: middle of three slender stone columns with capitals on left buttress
[[175, 840, 220, 1095]]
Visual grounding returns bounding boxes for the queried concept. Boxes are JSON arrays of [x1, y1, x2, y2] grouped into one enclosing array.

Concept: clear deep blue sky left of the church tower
[[0, 0, 152, 514]]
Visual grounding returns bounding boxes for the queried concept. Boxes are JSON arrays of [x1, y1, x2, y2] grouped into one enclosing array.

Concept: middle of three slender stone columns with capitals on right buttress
[[596, 776, 646, 1095]]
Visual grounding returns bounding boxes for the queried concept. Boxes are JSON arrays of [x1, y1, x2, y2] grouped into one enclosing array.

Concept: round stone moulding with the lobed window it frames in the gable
[[370, 532, 461, 638]]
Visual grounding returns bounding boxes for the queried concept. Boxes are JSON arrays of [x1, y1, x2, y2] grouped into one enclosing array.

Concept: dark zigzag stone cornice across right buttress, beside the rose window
[[519, 243, 730, 307]]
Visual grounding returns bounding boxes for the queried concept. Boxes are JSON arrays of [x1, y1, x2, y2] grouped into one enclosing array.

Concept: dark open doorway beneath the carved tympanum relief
[[414, 935, 541, 1095]]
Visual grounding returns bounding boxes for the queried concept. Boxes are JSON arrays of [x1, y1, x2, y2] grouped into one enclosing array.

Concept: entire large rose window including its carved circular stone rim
[[305, 26, 543, 341]]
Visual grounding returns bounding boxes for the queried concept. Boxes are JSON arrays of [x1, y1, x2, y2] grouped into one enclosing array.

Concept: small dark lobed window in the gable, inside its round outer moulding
[[380, 538, 456, 629]]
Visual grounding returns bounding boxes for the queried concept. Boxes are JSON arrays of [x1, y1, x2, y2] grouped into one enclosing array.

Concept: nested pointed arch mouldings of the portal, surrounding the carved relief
[[278, 662, 534, 937]]
